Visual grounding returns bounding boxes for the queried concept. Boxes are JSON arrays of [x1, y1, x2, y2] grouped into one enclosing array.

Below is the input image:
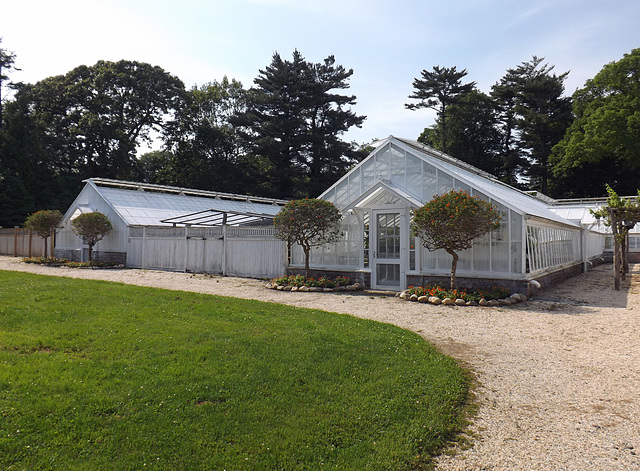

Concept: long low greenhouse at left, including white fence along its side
[[55, 178, 286, 278]]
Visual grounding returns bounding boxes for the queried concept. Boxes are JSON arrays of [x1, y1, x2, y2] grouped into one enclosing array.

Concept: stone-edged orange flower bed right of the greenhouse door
[[398, 286, 527, 306]]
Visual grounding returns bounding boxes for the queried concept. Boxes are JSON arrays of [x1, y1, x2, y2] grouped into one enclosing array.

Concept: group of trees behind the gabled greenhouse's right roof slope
[[406, 49, 640, 198]]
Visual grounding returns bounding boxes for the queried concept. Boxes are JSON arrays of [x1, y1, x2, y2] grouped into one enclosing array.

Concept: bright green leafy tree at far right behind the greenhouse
[[551, 49, 640, 197]]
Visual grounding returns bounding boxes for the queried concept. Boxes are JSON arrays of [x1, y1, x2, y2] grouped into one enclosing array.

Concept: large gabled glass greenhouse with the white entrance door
[[291, 136, 605, 290]]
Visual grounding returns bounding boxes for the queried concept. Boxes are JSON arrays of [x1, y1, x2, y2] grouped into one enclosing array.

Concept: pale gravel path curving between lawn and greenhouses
[[0, 256, 640, 471]]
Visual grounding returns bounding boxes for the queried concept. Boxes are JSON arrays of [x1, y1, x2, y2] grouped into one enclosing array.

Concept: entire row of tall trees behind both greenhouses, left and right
[[0, 40, 640, 227]]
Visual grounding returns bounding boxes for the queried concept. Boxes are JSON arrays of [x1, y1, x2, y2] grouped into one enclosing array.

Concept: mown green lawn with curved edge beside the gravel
[[0, 271, 468, 471]]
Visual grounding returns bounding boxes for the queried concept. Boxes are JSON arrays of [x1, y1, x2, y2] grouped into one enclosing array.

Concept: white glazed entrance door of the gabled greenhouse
[[371, 211, 405, 291]]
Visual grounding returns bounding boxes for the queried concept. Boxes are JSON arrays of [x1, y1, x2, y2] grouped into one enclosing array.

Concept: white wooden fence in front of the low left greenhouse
[[127, 226, 287, 278]]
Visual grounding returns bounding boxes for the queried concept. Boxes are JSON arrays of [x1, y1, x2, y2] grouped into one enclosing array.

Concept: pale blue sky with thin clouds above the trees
[[0, 0, 640, 147]]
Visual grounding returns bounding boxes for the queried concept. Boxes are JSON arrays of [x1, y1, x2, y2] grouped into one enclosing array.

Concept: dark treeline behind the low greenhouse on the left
[[0, 51, 366, 226]]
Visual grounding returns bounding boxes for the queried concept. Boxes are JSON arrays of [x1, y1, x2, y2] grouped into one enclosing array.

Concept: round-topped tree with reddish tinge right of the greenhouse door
[[411, 190, 500, 289]]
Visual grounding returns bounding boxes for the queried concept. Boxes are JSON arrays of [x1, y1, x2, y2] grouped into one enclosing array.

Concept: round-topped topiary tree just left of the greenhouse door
[[273, 198, 342, 277]]
